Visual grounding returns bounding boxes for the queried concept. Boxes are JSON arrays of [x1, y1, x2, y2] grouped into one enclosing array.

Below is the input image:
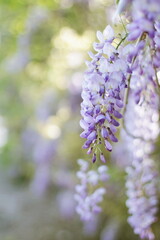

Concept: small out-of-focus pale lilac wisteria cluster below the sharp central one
[[75, 159, 109, 221]]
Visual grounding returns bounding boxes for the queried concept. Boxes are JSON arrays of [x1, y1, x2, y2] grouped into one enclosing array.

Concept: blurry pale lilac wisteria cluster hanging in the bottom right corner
[[126, 158, 158, 240]]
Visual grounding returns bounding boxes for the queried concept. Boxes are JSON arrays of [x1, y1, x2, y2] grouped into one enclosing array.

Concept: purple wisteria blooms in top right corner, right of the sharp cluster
[[119, 0, 160, 99]]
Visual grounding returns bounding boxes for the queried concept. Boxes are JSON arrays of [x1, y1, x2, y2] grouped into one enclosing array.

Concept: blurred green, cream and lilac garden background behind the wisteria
[[0, 0, 159, 240]]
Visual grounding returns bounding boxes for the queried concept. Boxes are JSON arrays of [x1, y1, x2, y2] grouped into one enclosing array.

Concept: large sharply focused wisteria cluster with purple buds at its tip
[[80, 26, 128, 162]]
